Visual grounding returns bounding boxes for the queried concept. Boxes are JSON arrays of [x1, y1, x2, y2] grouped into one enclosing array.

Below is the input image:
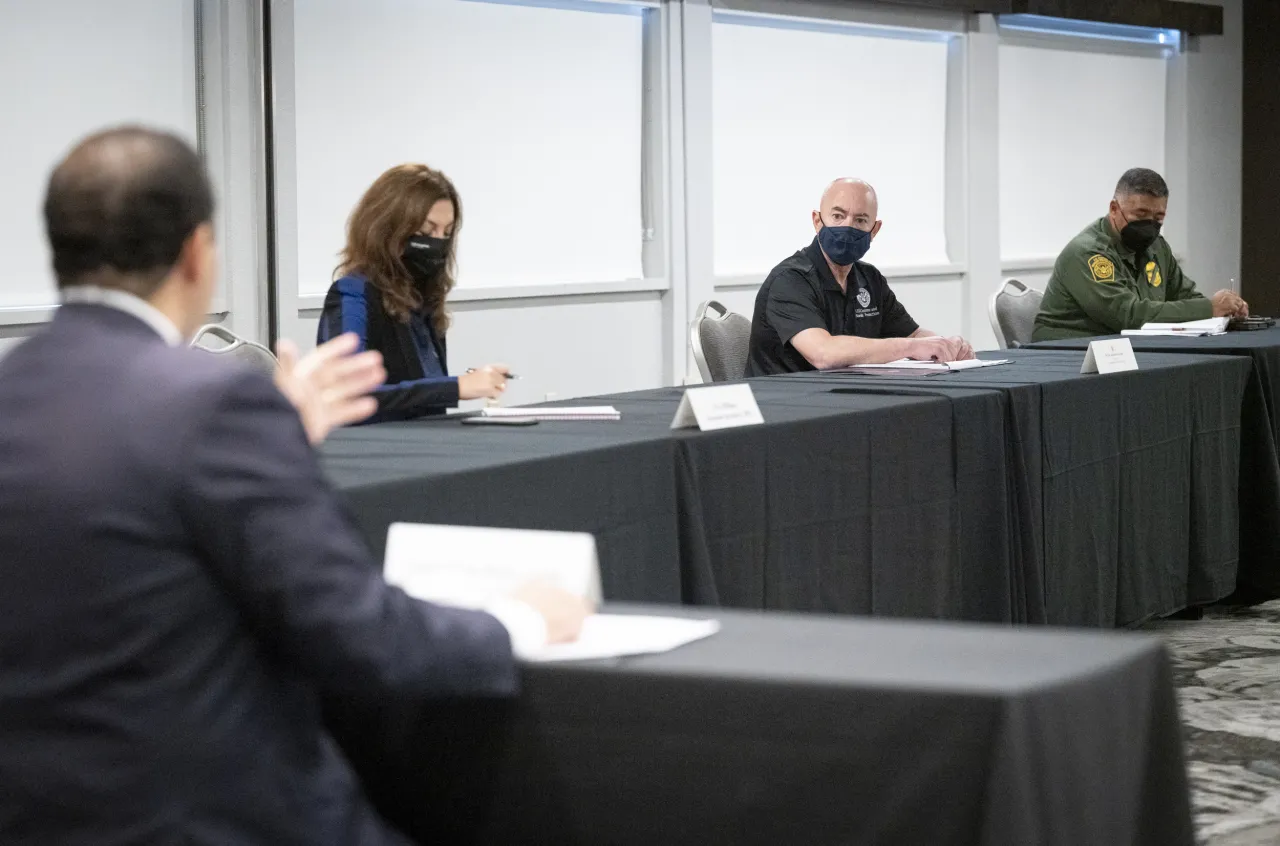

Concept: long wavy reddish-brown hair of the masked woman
[[335, 164, 462, 335]]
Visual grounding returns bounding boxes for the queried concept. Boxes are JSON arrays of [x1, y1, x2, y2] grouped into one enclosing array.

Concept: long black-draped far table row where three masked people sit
[[323, 351, 1251, 627]]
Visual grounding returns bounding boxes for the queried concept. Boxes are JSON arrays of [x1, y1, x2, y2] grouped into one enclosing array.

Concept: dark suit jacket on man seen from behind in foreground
[[0, 305, 517, 846]]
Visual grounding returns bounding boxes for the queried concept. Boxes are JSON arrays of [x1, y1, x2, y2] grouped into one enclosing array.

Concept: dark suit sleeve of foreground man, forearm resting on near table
[[180, 372, 517, 699]]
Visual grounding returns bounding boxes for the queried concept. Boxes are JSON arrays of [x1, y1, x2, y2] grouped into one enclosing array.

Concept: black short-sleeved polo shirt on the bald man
[[746, 238, 920, 376]]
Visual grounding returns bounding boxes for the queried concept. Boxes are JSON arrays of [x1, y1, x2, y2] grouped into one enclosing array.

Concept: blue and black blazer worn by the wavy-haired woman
[[316, 276, 458, 422]]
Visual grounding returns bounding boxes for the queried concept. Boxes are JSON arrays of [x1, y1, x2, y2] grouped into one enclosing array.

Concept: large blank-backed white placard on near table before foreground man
[[383, 523, 600, 608]]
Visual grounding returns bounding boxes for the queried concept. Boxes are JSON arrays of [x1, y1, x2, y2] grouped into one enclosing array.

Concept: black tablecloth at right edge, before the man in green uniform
[[1033, 328, 1280, 599]]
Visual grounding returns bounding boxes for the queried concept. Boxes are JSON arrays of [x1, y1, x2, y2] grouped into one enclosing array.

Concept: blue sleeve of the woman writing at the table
[[316, 280, 458, 422]]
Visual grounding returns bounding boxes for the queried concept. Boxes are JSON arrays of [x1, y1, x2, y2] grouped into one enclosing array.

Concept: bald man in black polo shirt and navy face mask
[[746, 178, 973, 376]]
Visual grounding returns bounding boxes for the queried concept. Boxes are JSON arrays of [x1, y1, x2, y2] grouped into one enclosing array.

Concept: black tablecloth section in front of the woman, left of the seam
[[321, 417, 689, 603]]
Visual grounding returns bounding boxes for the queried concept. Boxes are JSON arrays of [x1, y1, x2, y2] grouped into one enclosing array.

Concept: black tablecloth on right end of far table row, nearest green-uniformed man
[[794, 349, 1248, 626]]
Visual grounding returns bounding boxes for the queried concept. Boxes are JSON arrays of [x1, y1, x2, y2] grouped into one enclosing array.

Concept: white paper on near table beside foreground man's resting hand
[[526, 614, 719, 662]]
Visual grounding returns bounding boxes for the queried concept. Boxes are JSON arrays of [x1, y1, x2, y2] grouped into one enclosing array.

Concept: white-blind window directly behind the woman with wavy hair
[[293, 0, 644, 296]]
